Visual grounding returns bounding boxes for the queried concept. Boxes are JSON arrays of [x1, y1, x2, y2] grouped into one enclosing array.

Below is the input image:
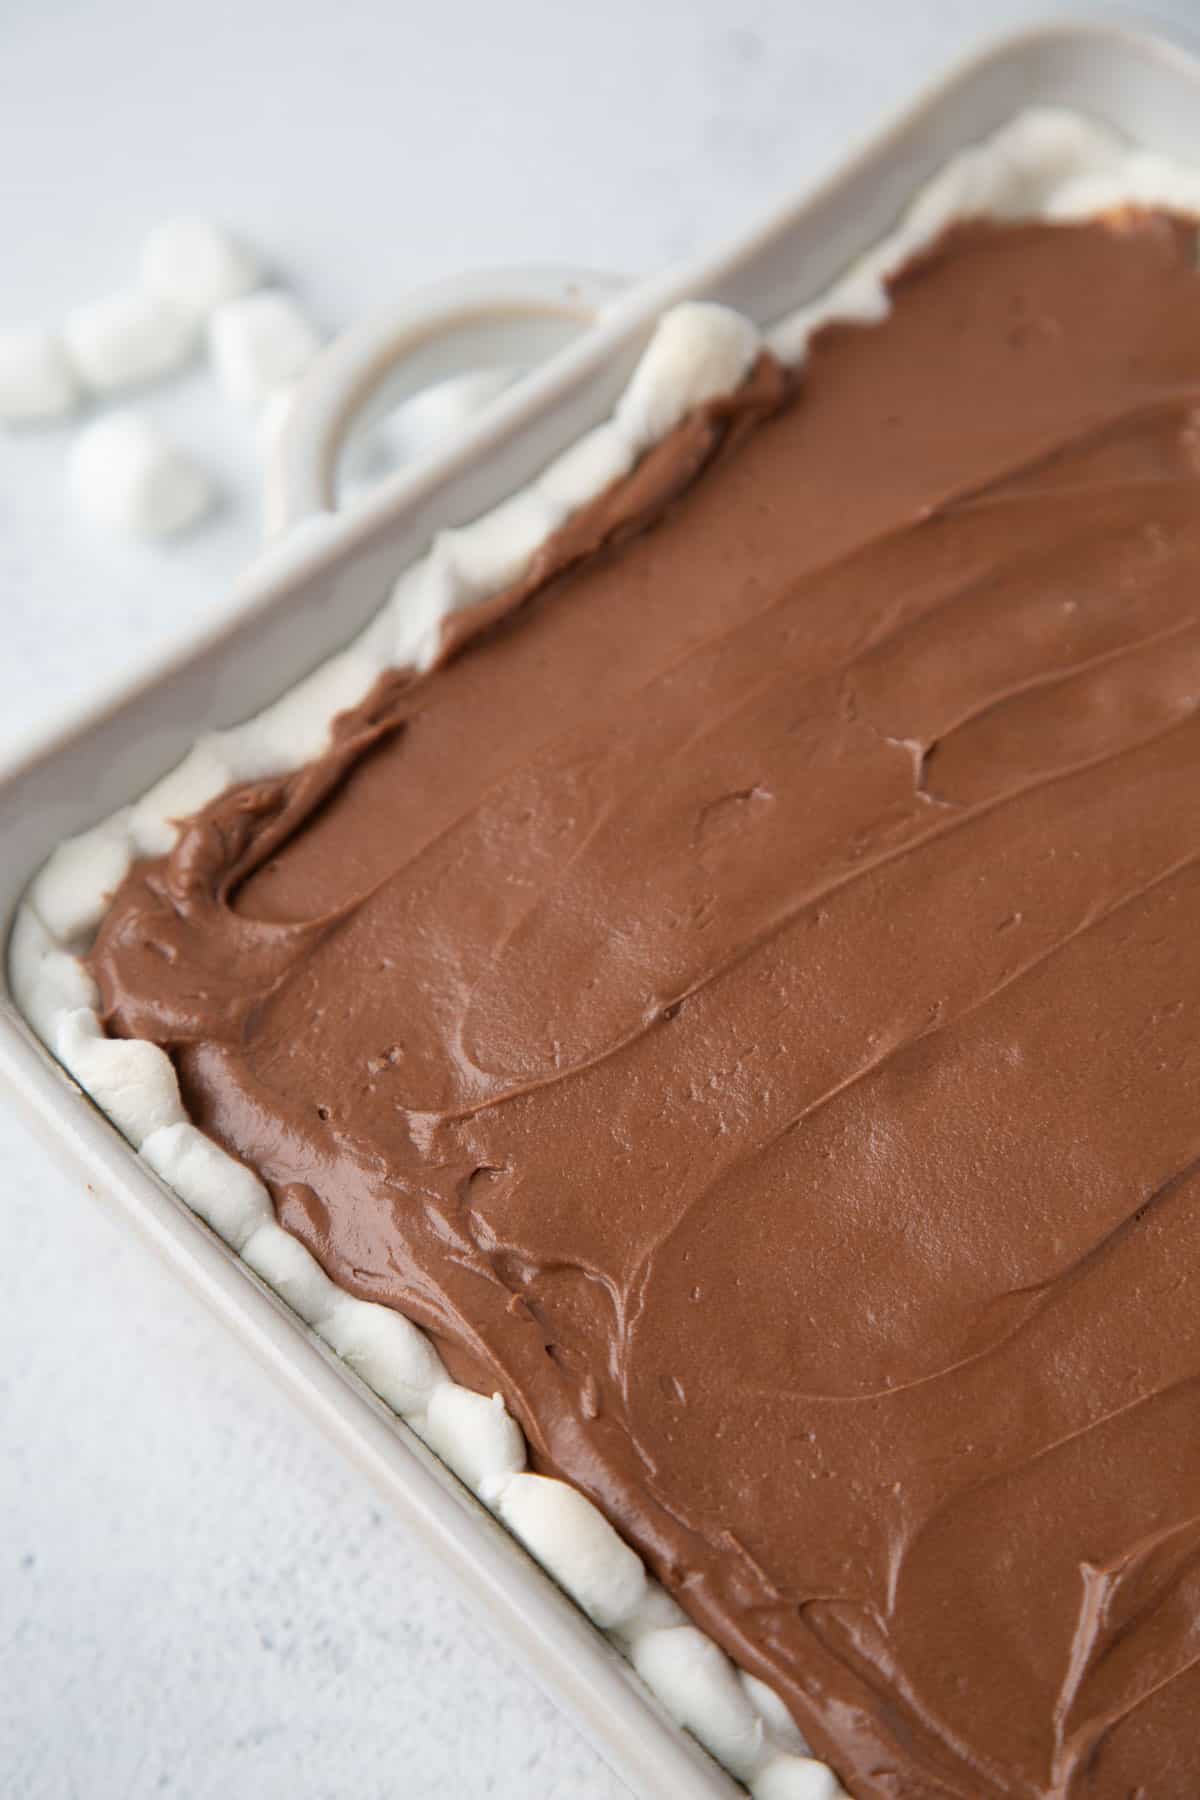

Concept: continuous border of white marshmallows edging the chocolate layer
[[9, 110, 1180, 1800]]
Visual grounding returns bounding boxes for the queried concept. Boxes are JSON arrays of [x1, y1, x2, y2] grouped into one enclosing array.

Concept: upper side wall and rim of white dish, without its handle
[[0, 17, 1200, 972]]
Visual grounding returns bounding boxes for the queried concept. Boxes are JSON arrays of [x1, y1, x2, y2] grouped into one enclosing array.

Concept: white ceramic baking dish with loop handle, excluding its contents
[[0, 25, 1200, 1800]]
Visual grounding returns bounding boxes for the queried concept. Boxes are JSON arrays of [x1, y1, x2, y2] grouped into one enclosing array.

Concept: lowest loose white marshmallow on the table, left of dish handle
[[68, 410, 214, 538]]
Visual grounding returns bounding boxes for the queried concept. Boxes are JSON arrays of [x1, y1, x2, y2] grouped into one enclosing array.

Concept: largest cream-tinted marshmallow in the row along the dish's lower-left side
[[497, 1474, 646, 1631]]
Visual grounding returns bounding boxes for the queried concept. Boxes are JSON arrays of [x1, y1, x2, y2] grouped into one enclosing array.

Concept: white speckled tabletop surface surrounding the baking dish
[[0, 0, 1200, 1800]]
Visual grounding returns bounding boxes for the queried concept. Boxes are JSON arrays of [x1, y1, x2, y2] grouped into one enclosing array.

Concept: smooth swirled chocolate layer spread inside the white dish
[[92, 214, 1200, 1800]]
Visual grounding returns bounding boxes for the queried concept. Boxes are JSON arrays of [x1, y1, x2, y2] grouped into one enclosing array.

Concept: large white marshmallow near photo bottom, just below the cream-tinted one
[[630, 1625, 765, 1778]]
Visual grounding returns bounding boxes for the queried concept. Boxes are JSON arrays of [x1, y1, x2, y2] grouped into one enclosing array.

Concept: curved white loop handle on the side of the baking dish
[[264, 268, 626, 536]]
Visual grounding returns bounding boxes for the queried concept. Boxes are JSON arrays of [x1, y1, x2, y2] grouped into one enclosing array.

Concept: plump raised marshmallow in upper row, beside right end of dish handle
[[615, 301, 763, 452]]
